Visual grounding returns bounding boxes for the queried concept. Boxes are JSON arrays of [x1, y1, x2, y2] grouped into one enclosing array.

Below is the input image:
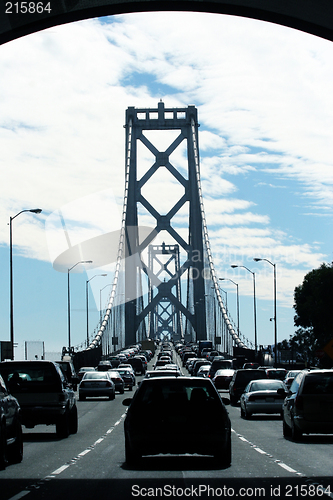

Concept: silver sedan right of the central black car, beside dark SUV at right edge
[[240, 379, 287, 419]]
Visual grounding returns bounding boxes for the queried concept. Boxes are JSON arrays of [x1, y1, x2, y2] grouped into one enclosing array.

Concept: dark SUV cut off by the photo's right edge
[[283, 370, 333, 441]]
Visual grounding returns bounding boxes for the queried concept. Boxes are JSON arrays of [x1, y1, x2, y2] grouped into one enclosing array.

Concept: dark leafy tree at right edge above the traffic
[[292, 264, 333, 362]]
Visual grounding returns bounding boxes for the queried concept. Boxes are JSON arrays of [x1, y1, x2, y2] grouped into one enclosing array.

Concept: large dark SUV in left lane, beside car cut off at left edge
[[0, 360, 78, 438]]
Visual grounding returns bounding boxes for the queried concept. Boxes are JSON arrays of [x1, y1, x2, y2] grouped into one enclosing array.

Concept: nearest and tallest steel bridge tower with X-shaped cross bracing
[[125, 102, 206, 345]]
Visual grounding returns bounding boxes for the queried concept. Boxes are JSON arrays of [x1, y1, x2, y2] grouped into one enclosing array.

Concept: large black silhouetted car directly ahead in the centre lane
[[123, 376, 231, 467]]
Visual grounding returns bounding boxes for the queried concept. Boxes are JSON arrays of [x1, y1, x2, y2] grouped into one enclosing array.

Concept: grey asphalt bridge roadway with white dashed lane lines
[[0, 352, 333, 500]]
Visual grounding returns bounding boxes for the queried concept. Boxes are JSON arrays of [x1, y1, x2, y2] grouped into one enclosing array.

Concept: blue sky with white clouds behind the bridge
[[0, 12, 333, 359]]
